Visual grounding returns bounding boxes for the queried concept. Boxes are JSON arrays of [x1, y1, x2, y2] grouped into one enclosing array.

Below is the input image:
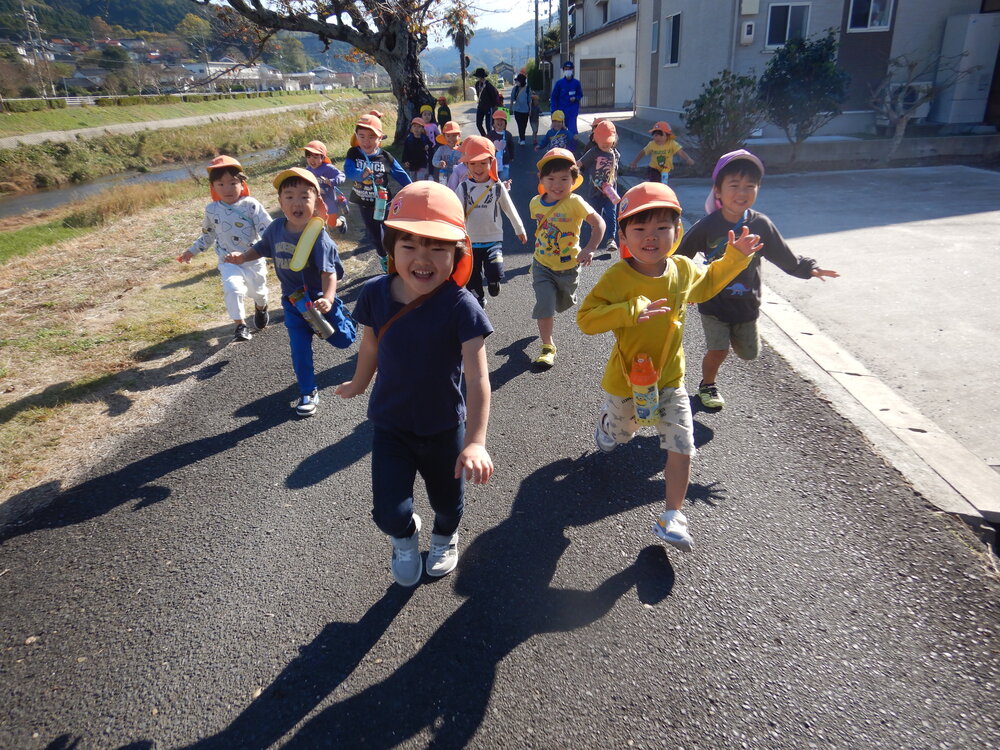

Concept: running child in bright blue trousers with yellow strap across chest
[[226, 167, 355, 417]]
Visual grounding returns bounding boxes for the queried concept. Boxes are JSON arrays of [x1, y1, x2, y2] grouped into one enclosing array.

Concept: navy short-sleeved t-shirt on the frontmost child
[[354, 276, 493, 435]]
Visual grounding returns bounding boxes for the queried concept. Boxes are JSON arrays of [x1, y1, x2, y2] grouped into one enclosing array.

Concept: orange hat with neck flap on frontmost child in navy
[[385, 180, 472, 286]]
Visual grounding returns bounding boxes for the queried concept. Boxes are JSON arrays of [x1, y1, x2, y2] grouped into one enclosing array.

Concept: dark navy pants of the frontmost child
[[372, 424, 465, 539]]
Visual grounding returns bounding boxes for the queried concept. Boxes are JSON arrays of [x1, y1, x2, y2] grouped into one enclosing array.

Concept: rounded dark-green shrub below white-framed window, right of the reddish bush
[[759, 29, 850, 161]]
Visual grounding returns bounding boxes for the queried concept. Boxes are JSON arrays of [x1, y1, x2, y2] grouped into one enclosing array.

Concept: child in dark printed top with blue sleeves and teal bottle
[[344, 114, 412, 272]]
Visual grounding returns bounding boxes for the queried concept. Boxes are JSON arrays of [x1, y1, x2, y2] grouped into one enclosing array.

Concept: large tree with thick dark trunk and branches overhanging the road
[[197, 0, 448, 142]]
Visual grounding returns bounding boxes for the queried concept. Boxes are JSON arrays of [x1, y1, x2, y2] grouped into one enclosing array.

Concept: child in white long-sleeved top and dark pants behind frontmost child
[[455, 135, 528, 307]]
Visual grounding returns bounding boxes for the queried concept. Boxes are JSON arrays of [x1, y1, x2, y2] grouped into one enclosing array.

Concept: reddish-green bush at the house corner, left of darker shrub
[[681, 70, 764, 172]]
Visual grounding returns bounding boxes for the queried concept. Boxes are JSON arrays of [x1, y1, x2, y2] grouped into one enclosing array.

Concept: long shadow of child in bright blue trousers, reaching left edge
[[0, 360, 354, 544]]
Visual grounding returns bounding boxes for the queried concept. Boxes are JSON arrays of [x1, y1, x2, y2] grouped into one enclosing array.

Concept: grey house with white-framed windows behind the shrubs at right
[[636, 0, 1000, 135]]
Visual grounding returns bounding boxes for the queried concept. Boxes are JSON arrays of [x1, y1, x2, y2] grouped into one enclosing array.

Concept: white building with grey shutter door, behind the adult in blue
[[568, 0, 636, 109]]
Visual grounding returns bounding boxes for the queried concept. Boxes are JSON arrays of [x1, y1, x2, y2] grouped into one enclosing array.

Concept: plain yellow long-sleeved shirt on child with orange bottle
[[576, 245, 752, 398]]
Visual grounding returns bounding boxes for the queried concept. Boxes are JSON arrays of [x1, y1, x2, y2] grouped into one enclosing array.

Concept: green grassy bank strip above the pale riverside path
[[0, 89, 361, 138]]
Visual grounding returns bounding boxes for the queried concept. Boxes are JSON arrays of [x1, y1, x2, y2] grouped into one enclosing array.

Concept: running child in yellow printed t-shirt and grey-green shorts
[[529, 148, 605, 369]]
